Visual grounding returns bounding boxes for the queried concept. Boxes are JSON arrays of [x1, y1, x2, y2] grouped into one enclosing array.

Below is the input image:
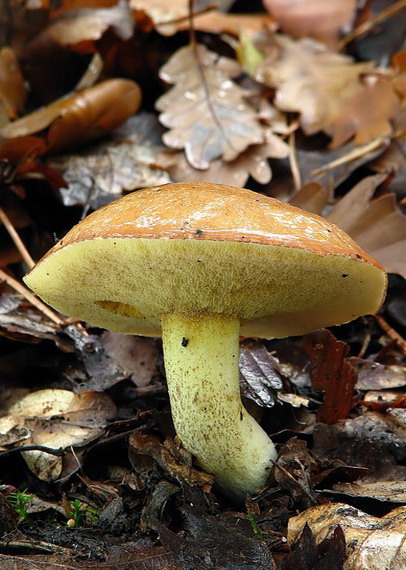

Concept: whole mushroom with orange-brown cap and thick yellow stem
[[25, 183, 386, 499]]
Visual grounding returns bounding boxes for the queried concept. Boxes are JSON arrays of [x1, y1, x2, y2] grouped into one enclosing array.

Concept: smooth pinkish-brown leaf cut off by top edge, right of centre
[[263, 0, 356, 44]]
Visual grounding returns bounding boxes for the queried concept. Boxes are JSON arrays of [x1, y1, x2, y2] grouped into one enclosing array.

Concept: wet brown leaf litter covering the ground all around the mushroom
[[0, 0, 406, 570]]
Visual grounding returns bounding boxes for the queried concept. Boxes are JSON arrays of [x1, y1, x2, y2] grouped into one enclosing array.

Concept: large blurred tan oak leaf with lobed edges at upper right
[[256, 35, 400, 147]]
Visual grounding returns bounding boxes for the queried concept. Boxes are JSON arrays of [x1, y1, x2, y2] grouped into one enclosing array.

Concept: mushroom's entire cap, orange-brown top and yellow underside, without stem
[[25, 183, 386, 338]]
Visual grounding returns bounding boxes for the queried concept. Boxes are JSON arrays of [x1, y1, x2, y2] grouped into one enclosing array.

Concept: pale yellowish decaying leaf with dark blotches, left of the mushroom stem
[[0, 389, 116, 481]]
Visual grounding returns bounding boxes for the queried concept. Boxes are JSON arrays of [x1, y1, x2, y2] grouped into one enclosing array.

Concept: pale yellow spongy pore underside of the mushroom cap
[[25, 237, 386, 338]]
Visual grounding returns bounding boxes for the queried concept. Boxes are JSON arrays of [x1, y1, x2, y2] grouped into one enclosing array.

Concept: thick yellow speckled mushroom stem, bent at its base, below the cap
[[162, 314, 277, 499]]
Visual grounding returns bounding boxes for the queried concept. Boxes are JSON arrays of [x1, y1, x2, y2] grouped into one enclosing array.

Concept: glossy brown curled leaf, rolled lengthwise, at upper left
[[0, 79, 141, 152]]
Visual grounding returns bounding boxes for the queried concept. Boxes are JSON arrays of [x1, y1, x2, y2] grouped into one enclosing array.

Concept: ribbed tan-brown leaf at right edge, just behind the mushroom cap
[[326, 174, 406, 277]]
